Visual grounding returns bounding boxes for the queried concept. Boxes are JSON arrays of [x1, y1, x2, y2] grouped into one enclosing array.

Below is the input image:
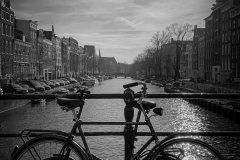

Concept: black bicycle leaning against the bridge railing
[[12, 82, 224, 160]]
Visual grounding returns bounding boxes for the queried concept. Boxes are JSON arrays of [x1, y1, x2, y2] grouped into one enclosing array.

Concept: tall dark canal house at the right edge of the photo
[[205, 0, 240, 82]]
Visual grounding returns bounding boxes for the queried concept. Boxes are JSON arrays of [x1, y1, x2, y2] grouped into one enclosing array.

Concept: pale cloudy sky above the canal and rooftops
[[11, 0, 215, 64]]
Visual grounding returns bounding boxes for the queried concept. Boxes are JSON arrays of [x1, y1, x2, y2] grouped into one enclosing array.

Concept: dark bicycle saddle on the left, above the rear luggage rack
[[57, 98, 85, 110]]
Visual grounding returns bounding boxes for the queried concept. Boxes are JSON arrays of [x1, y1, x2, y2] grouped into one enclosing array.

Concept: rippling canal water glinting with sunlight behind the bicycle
[[0, 78, 240, 160]]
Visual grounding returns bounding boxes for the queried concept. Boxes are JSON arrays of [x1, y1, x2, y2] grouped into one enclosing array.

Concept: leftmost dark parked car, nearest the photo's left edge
[[2, 83, 28, 94]]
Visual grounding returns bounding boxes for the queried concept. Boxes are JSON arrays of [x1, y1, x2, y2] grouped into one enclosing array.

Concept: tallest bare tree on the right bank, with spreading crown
[[166, 23, 192, 81]]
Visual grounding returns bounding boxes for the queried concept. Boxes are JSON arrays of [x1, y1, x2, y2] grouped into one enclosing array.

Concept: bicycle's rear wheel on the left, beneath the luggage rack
[[12, 135, 88, 160]]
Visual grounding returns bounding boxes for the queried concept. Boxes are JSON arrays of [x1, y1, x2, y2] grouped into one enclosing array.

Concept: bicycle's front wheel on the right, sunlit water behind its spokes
[[147, 138, 224, 160]]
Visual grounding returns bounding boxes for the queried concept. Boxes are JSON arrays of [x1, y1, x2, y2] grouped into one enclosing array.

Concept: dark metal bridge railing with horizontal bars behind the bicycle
[[0, 93, 240, 159]]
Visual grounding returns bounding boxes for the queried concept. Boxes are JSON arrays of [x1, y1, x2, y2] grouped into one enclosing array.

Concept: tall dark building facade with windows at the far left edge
[[0, 0, 14, 78]]
